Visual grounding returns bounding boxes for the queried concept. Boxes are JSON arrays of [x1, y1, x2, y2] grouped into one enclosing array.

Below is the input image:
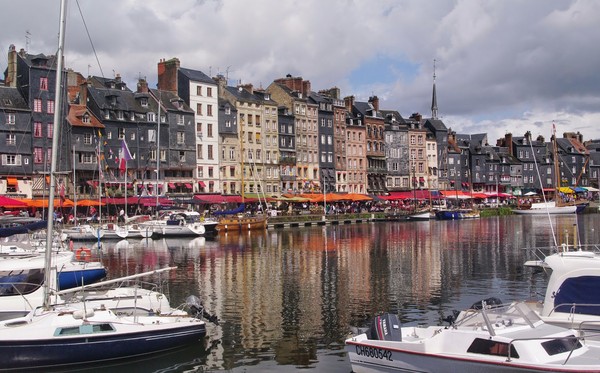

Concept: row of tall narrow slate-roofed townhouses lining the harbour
[[0, 45, 600, 198]]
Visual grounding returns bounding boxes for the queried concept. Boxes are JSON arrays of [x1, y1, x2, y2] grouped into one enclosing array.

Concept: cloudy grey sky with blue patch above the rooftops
[[0, 0, 600, 145]]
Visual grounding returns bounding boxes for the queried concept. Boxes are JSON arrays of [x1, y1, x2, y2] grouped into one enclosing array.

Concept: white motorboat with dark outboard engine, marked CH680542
[[346, 303, 600, 373]]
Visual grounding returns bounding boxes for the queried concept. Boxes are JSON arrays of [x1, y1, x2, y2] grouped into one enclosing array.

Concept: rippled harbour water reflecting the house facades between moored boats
[[95, 215, 598, 372]]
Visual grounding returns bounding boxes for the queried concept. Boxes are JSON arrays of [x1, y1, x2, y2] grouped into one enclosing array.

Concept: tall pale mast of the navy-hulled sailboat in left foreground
[[44, 0, 67, 308]]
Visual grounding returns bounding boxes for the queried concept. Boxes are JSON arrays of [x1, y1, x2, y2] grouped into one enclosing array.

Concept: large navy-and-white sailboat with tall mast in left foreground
[[0, 0, 206, 370]]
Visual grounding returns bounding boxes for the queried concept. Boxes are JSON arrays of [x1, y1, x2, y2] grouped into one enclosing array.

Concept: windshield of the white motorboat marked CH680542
[[454, 302, 541, 335]]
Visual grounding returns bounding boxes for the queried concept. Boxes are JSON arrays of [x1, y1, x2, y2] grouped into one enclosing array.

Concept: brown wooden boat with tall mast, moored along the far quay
[[215, 119, 268, 232]]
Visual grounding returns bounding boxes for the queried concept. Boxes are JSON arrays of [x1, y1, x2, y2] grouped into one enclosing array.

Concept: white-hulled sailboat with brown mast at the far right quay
[[513, 124, 587, 215]]
